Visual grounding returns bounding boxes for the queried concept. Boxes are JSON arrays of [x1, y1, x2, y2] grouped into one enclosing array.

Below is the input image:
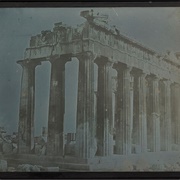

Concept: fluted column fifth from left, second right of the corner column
[[113, 63, 133, 154]]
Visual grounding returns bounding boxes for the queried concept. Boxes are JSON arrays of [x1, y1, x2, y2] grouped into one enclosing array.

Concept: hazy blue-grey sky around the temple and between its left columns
[[0, 7, 180, 134]]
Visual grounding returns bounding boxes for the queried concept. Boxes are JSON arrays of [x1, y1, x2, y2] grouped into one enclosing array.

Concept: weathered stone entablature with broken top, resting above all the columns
[[25, 9, 179, 82]]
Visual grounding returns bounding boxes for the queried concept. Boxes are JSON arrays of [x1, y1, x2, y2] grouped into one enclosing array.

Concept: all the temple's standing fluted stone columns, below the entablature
[[18, 52, 180, 158]]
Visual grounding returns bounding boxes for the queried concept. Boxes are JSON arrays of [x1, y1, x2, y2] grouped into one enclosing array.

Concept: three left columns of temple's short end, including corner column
[[18, 53, 95, 157]]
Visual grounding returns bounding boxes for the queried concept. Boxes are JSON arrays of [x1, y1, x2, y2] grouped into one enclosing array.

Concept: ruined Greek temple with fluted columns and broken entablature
[[17, 11, 180, 158]]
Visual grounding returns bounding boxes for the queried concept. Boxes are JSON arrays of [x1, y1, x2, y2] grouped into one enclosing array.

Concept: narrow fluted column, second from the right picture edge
[[163, 80, 172, 151]]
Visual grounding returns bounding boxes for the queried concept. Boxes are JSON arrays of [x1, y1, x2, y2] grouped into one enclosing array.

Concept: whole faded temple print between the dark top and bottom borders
[[0, 8, 180, 172]]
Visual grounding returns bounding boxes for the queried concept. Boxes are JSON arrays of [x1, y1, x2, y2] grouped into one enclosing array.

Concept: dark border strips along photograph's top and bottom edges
[[0, 0, 180, 179]]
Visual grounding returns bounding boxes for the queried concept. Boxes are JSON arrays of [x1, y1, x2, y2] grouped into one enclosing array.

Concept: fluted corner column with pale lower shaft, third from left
[[76, 52, 96, 158]]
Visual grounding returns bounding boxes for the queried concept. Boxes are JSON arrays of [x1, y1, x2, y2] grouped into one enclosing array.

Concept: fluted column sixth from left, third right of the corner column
[[132, 69, 147, 152]]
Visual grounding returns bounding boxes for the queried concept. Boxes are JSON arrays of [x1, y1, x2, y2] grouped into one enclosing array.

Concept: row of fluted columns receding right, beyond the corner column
[[95, 57, 180, 156]]
